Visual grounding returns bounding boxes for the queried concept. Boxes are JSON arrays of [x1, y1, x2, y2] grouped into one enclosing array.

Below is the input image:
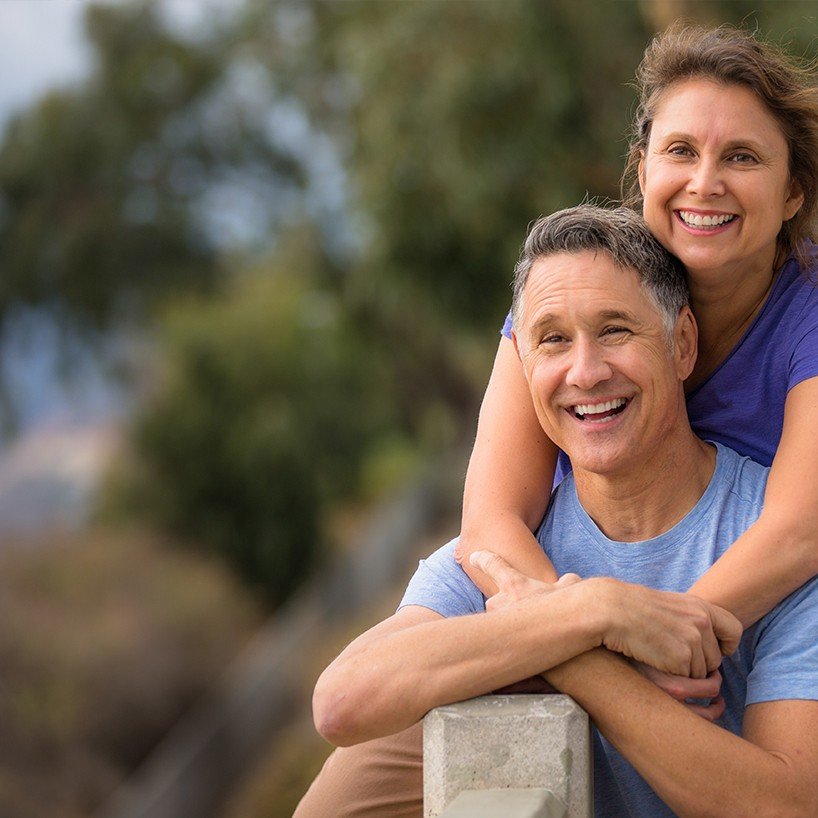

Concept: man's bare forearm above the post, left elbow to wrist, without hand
[[313, 588, 598, 745]]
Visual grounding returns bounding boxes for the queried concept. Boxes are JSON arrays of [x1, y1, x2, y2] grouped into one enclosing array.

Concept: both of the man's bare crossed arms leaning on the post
[[313, 555, 818, 816]]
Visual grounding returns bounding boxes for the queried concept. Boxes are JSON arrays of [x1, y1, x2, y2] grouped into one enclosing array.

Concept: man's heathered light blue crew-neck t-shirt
[[400, 444, 818, 818]]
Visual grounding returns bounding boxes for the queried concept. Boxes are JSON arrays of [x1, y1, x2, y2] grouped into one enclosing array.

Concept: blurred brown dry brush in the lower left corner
[[0, 531, 261, 818]]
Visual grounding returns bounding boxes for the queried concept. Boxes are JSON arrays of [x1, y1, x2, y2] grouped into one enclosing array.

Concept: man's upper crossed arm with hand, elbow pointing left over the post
[[313, 557, 741, 746]]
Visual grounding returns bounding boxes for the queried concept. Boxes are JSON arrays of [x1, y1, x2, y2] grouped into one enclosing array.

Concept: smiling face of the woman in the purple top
[[639, 78, 803, 287]]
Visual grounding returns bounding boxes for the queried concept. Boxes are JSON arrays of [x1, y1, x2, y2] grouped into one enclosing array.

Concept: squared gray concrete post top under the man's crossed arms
[[423, 694, 593, 818]]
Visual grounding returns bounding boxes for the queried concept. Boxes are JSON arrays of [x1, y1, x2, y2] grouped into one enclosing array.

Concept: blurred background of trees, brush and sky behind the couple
[[0, 0, 818, 818]]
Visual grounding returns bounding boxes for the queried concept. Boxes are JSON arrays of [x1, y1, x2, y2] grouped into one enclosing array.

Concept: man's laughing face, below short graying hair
[[515, 251, 695, 475]]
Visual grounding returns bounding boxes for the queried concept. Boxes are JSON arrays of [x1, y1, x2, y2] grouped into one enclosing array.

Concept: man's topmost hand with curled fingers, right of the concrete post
[[588, 578, 742, 679]]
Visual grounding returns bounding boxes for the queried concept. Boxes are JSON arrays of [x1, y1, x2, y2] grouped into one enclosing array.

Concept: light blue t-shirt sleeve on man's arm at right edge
[[747, 579, 818, 705]]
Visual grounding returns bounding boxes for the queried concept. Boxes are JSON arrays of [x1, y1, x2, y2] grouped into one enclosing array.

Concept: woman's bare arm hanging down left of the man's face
[[457, 337, 557, 596]]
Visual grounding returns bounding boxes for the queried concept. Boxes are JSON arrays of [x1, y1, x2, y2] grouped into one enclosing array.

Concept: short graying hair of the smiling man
[[511, 204, 689, 336]]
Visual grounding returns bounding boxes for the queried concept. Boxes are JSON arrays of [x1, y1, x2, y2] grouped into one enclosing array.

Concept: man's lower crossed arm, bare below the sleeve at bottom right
[[544, 650, 818, 818]]
